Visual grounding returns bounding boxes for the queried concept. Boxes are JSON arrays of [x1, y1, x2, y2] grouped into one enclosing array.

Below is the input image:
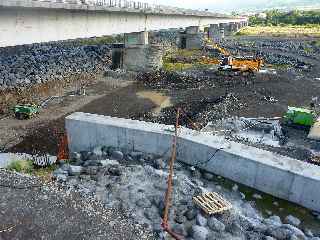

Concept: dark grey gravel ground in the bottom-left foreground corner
[[0, 169, 152, 240]]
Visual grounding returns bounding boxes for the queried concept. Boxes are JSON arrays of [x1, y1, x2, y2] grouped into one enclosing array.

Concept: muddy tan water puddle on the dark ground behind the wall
[[137, 91, 173, 116]]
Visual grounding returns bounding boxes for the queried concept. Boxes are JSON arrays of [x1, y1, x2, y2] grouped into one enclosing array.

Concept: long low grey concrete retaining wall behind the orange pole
[[66, 113, 320, 211]]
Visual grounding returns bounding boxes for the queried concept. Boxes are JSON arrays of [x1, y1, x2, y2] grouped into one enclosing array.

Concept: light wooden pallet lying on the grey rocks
[[193, 192, 232, 215]]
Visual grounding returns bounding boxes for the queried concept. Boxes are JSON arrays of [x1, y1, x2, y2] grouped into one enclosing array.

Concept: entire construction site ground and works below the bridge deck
[[0, 0, 320, 240]]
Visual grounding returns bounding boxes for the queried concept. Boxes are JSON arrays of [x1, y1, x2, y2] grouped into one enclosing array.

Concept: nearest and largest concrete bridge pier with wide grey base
[[123, 31, 162, 71]]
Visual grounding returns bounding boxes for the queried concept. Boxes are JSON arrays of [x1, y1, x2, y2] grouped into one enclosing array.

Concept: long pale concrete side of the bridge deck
[[0, 0, 248, 47]]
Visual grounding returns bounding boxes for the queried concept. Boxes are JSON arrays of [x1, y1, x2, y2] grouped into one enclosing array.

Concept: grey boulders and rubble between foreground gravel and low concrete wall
[[54, 147, 320, 240]]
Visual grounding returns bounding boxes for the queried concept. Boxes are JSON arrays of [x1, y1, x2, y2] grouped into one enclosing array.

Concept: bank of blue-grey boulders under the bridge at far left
[[0, 41, 111, 89]]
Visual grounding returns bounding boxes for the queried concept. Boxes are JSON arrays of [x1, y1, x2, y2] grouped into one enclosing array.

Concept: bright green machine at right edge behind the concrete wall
[[284, 107, 316, 127]]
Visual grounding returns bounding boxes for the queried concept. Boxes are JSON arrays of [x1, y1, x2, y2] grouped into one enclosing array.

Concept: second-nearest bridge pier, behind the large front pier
[[179, 26, 203, 50]]
